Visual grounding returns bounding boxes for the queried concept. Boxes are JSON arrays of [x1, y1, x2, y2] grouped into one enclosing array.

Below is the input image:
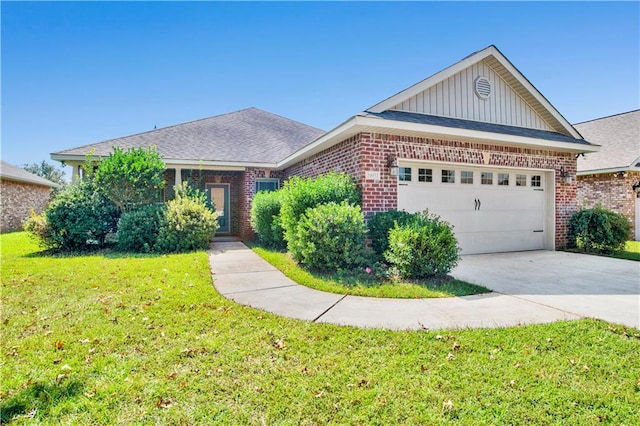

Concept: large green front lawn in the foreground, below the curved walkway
[[0, 233, 640, 425]]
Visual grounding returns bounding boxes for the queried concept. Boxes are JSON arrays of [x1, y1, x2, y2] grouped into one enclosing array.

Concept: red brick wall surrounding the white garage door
[[285, 133, 577, 248]]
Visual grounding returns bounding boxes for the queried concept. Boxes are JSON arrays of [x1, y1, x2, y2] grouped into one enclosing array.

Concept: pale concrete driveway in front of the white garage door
[[452, 251, 640, 328]]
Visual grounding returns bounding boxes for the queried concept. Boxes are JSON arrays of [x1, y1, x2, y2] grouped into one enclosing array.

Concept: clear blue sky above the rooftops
[[1, 2, 640, 171]]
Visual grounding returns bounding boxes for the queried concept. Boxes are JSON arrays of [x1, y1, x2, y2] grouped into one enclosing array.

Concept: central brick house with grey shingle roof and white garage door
[[52, 46, 598, 254]]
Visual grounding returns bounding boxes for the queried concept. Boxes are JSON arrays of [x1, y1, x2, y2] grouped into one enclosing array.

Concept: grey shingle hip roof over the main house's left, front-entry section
[[51, 108, 324, 165]]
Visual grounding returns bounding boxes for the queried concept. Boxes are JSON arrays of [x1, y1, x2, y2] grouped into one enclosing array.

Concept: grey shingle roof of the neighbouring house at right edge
[[574, 109, 640, 175]]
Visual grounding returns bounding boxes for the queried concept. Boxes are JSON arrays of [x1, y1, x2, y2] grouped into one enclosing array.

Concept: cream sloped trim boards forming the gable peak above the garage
[[368, 45, 582, 139]]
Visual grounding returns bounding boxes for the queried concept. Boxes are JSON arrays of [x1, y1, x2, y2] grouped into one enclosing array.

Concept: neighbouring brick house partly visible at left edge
[[0, 161, 60, 232]]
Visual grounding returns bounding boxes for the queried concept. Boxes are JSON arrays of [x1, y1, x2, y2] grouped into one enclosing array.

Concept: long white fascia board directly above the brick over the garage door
[[355, 116, 600, 153]]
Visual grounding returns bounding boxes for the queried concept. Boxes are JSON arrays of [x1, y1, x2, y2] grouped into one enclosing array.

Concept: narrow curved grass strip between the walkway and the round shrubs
[[252, 246, 491, 299]]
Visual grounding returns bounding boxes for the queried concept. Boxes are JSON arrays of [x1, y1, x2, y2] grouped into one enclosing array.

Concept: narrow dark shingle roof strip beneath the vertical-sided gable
[[366, 110, 589, 145]]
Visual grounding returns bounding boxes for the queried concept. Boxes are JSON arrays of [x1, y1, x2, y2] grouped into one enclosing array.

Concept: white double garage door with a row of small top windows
[[398, 164, 545, 254]]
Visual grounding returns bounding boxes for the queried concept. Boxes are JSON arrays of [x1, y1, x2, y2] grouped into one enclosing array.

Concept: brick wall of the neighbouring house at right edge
[[577, 172, 640, 235]]
